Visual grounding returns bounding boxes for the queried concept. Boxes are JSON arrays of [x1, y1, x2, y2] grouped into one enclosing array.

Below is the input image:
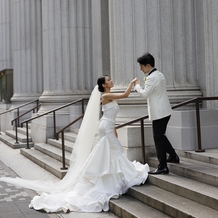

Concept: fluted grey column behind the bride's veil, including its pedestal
[[32, 0, 109, 141]]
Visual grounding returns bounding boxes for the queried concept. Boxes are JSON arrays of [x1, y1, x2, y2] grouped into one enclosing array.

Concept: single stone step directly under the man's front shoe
[[147, 173, 218, 210]]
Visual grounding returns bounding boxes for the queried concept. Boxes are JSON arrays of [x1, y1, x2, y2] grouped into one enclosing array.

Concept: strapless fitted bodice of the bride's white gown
[[101, 101, 119, 123]]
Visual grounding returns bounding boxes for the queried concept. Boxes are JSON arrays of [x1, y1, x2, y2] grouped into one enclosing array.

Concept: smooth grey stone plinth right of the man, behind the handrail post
[[167, 109, 218, 151]]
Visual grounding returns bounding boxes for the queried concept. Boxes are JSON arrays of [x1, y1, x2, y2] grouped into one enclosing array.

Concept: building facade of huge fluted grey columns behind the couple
[[0, 0, 218, 159]]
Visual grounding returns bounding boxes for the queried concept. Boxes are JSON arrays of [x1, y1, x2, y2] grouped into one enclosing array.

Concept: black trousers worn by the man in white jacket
[[152, 115, 176, 169]]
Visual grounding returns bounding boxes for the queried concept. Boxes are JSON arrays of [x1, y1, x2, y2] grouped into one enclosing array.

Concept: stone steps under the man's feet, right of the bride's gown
[[110, 149, 218, 218]]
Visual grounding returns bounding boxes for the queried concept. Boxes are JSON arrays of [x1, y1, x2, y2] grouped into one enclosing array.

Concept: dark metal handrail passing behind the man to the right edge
[[116, 96, 218, 163]]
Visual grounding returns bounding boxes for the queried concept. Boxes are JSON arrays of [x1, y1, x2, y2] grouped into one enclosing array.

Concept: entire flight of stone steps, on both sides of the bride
[[0, 125, 218, 218]]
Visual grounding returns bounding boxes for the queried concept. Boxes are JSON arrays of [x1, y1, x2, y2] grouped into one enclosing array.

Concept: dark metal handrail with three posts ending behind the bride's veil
[[21, 98, 88, 149]]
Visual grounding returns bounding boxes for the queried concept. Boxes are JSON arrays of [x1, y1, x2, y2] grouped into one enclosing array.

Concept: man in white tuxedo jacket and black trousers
[[134, 53, 179, 174]]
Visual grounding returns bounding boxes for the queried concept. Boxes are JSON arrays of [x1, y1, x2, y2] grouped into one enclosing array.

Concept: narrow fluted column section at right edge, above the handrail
[[195, 0, 218, 109]]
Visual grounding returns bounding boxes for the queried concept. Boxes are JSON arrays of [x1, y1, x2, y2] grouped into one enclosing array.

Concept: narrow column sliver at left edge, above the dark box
[[0, 0, 14, 71]]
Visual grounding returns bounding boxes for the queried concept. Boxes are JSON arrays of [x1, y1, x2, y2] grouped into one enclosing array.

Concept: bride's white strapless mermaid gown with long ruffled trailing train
[[0, 96, 149, 212]]
